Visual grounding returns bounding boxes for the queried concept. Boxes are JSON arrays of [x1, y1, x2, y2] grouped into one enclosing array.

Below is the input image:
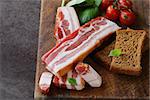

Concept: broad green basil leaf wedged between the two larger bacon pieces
[[78, 7, 99, 25]]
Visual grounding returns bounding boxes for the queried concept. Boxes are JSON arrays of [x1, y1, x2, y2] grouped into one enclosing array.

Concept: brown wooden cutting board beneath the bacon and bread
[[34, 0, 149, 99]]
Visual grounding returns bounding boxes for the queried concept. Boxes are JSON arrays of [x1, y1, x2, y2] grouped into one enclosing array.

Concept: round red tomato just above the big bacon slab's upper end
[[105, 5, 120, 21]]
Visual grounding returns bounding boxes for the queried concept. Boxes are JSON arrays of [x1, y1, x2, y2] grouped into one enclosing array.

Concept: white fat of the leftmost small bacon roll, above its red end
[[39, 72, 53, 87]]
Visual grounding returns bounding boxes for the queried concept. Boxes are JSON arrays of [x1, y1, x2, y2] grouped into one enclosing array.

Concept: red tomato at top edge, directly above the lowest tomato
[[118, 0, 132, 9]]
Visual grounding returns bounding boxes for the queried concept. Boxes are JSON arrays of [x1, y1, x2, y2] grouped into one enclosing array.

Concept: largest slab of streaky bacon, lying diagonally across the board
[[42, 17, 120, 76]]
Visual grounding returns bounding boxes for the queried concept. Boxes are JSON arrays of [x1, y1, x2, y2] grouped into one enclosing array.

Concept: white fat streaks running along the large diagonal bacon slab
[[48, 19, 120, 74]]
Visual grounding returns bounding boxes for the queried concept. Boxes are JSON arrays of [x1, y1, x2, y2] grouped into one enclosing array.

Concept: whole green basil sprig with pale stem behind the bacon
[[66, 0, 102, 25]]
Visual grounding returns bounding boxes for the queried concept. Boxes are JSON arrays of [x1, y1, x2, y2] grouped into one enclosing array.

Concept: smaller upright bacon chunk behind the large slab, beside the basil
[[54, 7, 80, 43]]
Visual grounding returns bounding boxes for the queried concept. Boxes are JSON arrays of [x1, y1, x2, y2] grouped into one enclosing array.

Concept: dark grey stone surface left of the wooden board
[[0, 0, 40, 100]]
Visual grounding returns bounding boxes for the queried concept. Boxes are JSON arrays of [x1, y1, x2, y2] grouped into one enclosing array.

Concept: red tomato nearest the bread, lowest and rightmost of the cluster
[[119, 10, 136, 26]]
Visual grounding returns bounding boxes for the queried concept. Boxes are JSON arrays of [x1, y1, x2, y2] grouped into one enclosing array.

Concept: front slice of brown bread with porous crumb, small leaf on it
[[110, 30, 146, 75]]
